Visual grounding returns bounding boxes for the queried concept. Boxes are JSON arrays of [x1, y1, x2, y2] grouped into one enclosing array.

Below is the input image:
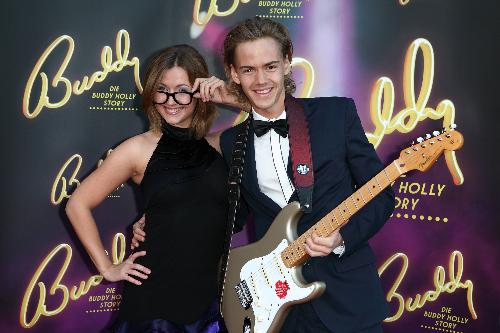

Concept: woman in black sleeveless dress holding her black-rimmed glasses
[[66, 45, 239, 333]]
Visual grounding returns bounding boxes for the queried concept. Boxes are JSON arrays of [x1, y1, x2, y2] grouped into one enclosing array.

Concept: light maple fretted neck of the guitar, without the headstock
[[281, 159, 404, 268]]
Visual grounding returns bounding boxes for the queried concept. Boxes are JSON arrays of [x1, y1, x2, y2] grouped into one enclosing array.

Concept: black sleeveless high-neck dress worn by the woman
[[112, 124, 228, 333]]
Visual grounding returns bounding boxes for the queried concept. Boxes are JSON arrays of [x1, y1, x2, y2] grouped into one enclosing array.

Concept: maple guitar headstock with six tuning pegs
[[398, 127, 464, 172]]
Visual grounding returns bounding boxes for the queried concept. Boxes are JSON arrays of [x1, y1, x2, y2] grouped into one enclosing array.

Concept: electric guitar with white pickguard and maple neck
[[221, 129, 463, 333]]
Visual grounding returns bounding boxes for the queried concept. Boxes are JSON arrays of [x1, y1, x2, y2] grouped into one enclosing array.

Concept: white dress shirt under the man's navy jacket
[[252, 110, 295, 208]]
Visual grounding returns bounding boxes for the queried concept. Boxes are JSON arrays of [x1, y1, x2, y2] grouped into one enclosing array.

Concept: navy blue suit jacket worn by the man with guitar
[[221, 97, 394, 333]]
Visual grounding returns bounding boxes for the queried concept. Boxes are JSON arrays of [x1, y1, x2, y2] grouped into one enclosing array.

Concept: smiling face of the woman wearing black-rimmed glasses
[[153, 66, 197, 128]]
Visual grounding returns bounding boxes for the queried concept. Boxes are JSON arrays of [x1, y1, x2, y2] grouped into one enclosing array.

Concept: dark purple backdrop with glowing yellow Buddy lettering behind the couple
[[0, 0, 500, 333]]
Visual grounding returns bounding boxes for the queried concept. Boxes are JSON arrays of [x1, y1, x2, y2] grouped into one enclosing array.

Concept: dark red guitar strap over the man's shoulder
[[285, 95, 314, 213]]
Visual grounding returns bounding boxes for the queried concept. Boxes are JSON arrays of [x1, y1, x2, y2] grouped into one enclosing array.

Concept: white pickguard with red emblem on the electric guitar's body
[[240, 239, 314, 333]]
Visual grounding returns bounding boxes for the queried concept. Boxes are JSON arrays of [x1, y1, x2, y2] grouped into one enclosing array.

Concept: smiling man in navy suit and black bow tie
[[220, 17, 394, 333]]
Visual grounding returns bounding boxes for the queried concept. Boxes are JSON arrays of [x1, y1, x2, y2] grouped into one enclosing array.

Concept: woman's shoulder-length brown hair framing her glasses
[[141, 44, 216, 139]]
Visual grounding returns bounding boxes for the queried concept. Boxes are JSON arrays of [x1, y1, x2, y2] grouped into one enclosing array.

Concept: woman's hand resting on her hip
[[101, 251, 151, 286]]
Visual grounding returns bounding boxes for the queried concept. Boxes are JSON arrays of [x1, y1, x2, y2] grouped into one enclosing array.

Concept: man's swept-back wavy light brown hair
[[224, 16, 295, 103]]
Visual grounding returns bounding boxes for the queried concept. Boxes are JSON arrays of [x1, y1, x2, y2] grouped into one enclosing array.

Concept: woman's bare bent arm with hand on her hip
[[66, 137, 150, 284]]
